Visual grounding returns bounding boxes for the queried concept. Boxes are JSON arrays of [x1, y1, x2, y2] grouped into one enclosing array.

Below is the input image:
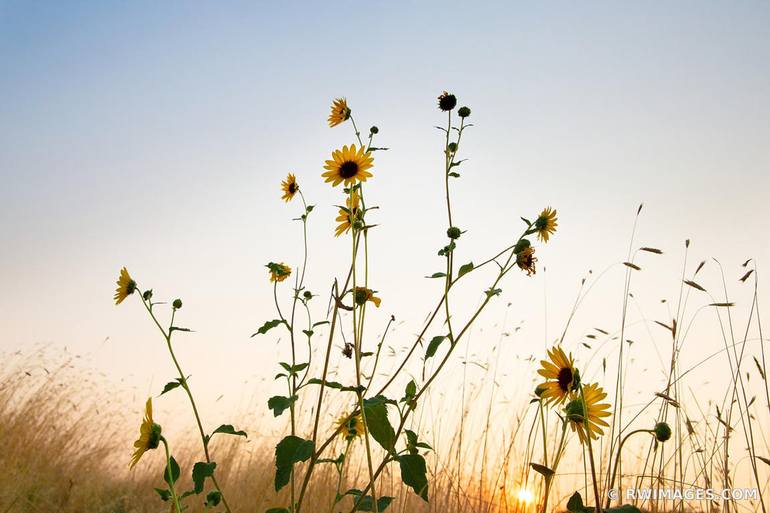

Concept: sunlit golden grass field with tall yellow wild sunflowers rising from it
[[0, 92, 770, 513]]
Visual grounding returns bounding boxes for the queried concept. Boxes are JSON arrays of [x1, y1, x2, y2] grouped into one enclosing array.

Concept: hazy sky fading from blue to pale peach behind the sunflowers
[[0, 1, 770, 432]]
